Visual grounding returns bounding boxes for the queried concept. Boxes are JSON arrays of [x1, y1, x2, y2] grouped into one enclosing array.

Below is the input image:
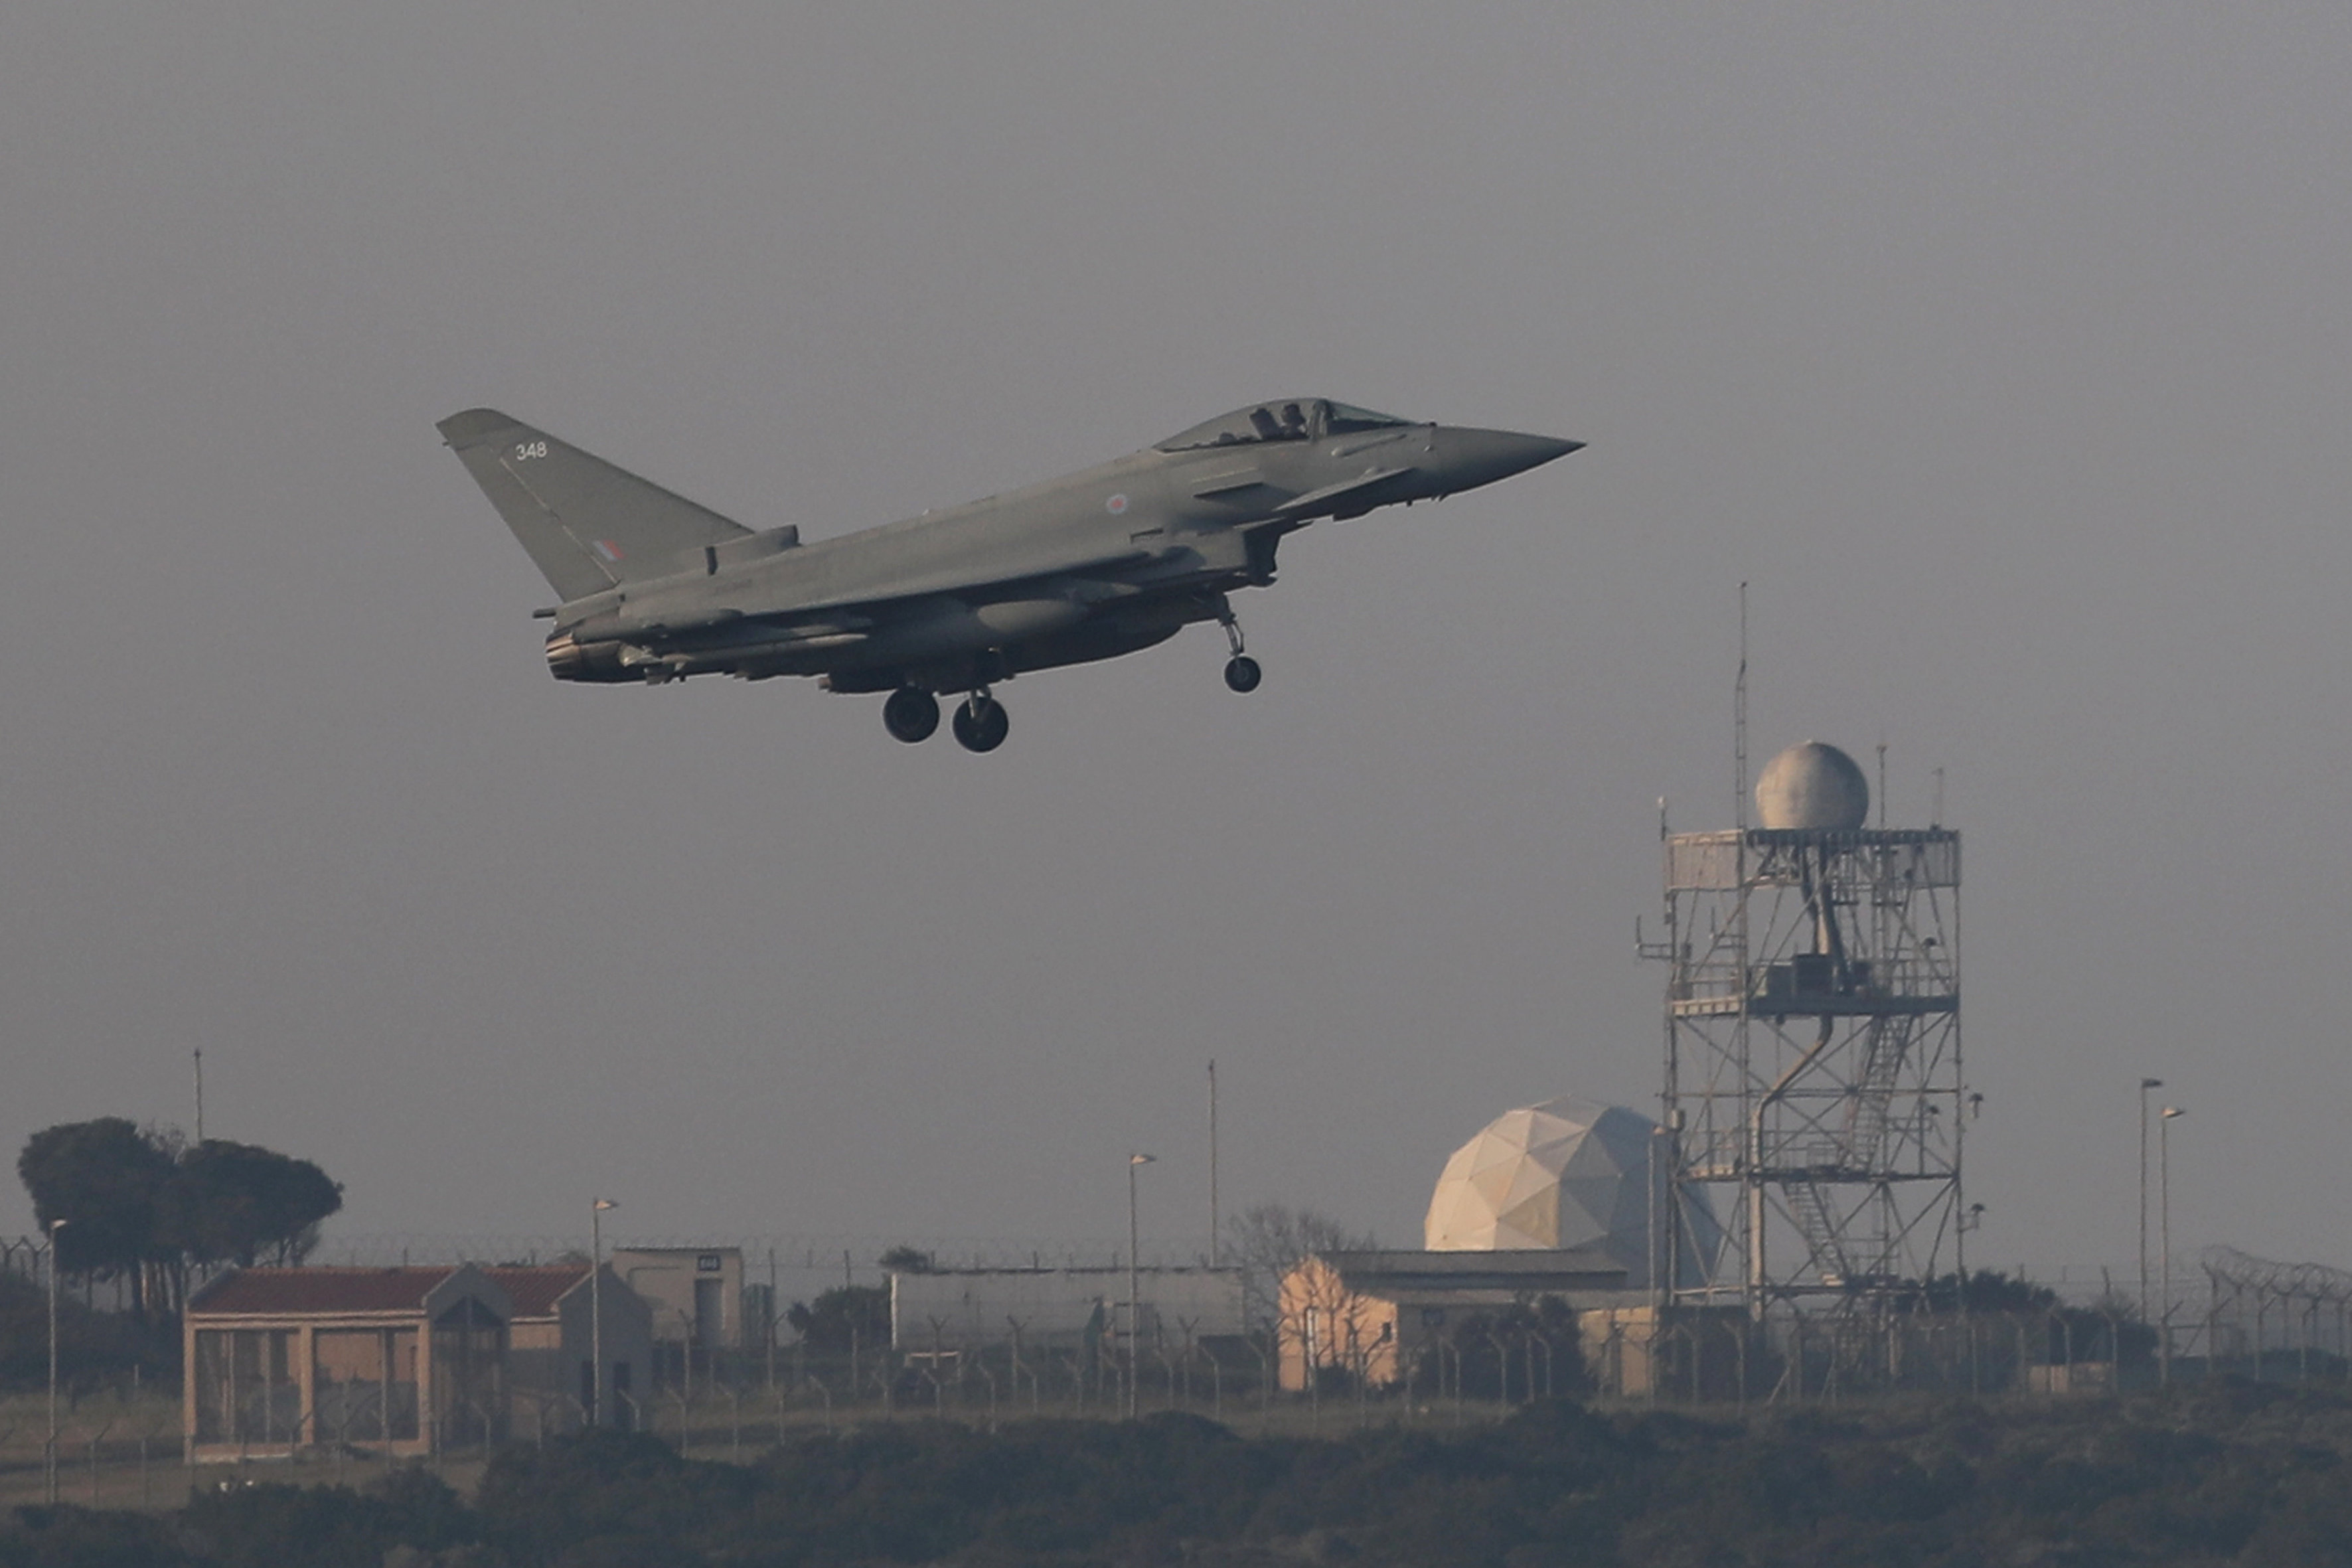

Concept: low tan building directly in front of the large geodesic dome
[[1275, 1246, 1651, 1391]]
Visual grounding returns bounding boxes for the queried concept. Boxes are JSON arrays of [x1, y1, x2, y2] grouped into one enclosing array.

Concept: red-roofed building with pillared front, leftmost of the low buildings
[[181, 1265, 512, 1462]]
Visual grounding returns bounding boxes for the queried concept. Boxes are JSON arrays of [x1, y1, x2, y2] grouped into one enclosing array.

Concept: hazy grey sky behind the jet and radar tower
[[0, 0, 2352, 1265]]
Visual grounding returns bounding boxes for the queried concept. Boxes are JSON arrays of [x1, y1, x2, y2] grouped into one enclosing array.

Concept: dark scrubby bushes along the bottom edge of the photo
[[13, 1382, 2352, 1568]]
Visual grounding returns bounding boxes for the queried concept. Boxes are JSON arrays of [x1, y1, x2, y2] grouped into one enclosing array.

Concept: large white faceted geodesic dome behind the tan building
[[1423, 1095, 1721, 1289]]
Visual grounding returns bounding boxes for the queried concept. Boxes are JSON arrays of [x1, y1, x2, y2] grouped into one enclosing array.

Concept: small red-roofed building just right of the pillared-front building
[[482, 1263, 654, 1437]]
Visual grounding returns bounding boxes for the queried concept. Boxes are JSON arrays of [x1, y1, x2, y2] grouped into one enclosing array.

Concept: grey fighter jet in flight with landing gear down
[[440, 397, 1583, 752]]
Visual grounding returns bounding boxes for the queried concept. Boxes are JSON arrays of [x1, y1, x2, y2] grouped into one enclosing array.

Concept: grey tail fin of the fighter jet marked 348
[[440, 409, 750, 599]]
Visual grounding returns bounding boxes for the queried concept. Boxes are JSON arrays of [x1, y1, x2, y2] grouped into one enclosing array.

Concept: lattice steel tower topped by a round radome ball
[[1644, 740, 1971, 1319]]
